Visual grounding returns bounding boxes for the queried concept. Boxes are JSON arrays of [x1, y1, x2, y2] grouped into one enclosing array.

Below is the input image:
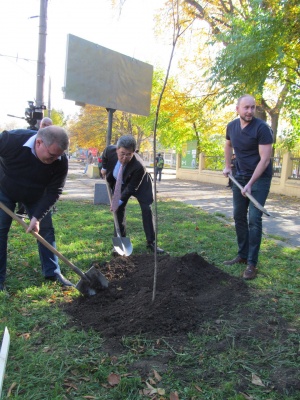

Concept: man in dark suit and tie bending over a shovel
[[101, 135, 164, 253]]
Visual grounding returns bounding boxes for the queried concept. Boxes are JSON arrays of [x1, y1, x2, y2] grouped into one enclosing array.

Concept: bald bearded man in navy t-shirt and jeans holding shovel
[[223, 94, 273, 279]]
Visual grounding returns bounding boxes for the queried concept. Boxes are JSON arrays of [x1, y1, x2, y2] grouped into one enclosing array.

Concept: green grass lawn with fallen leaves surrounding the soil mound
[[0, 200, 300, 400]]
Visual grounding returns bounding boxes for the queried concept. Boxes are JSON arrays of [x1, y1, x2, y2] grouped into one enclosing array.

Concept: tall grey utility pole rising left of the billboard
[[36, 0, 48, 124]]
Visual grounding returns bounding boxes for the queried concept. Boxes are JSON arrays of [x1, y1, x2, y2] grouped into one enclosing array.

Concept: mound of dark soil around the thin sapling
[[65, 253, 249, 338]]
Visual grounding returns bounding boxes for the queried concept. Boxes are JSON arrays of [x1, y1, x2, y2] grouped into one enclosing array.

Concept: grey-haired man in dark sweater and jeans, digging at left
[[0, 125, 71, 290]]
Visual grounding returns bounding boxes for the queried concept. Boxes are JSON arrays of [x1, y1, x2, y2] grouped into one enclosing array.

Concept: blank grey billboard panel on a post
[[64, 34, 153, 116]]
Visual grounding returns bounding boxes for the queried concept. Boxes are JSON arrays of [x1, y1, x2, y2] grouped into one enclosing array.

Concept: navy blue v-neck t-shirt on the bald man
[[226, 118, 273, 177]]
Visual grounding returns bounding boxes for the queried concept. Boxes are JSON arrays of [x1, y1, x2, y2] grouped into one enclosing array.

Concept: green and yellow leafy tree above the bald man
[[178, 0, 300, 145]]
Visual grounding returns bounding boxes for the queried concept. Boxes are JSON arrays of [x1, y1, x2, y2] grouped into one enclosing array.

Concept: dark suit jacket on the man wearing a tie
[[102, 145, 153, 204]]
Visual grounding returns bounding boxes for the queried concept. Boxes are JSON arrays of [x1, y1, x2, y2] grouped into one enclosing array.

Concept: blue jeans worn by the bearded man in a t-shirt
[[232, 176, 271, 266]]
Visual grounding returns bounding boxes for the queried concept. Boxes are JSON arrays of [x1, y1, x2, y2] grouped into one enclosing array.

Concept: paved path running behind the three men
[[62, 160, 300, 248]]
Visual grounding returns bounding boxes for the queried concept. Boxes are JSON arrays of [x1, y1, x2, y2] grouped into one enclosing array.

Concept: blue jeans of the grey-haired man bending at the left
[[0, 190, 60, 282]]
